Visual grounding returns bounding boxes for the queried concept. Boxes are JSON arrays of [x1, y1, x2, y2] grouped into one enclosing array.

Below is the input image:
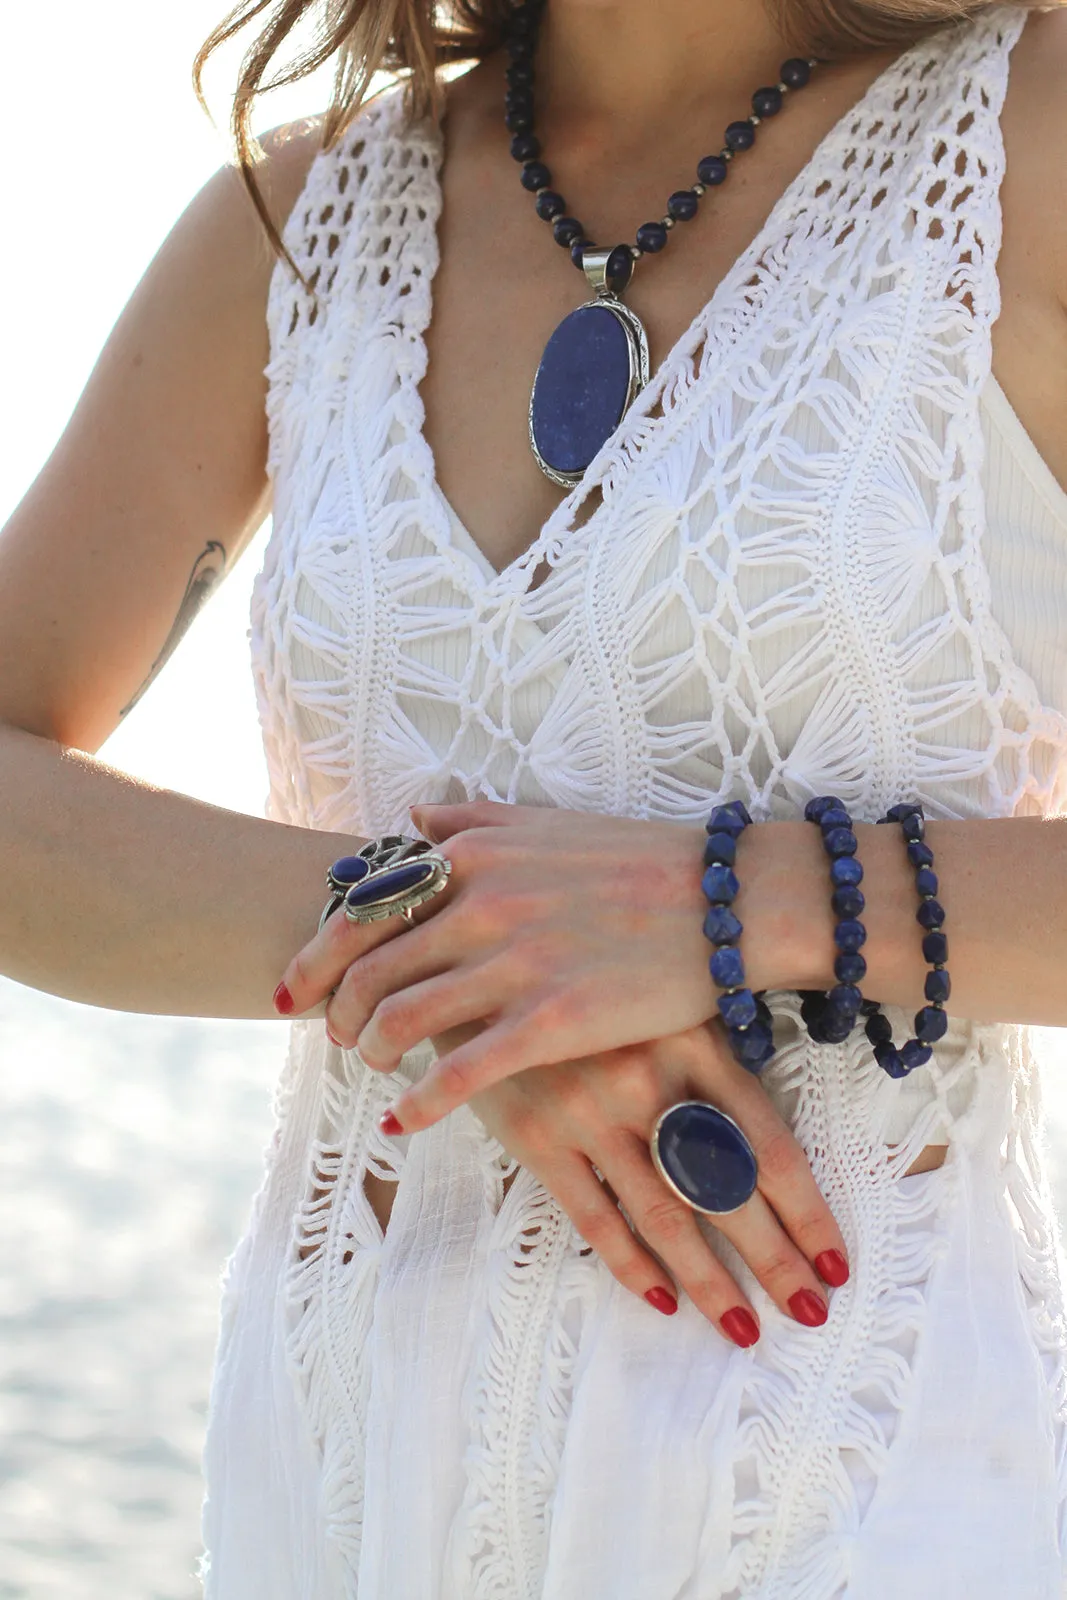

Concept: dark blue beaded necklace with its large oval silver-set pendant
[[504, 0, 819, 488]]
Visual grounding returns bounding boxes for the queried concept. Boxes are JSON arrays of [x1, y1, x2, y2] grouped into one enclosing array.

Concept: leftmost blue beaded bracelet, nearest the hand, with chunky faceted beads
[[701, 800, 774, 1072]]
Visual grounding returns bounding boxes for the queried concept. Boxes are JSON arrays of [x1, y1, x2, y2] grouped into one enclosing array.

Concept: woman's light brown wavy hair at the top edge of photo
[[192, 0, 1054, 277]]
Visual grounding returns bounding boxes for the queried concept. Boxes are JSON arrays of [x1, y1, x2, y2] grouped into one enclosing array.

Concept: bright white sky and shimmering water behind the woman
[[0, 0, 1067, 1600]]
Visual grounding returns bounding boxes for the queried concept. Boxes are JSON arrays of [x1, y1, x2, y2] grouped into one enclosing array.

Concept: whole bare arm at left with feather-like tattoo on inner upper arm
[[0, 125, 388, 1018]]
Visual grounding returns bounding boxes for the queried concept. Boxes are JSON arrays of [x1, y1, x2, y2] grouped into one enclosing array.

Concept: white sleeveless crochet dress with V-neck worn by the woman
[[205, 8, 1067, 1600]]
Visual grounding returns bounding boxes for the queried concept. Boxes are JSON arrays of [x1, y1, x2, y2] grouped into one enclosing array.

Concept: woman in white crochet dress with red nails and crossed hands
[[0, 0, 1067, 1600]]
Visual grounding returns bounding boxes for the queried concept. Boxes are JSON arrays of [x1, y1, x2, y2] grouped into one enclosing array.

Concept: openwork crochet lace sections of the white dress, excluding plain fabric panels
[[239, 8, 1067, 1600]]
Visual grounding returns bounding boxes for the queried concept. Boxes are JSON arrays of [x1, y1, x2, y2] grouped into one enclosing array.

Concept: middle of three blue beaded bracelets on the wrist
[[800, 795, 867, 1045]]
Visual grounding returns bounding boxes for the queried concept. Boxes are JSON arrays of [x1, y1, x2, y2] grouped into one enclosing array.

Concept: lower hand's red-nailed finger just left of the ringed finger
[[597, 1133, 760, 1349]]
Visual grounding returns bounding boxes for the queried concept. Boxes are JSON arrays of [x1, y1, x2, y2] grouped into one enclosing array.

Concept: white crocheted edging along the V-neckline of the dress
[[405, 24, 934, 594]]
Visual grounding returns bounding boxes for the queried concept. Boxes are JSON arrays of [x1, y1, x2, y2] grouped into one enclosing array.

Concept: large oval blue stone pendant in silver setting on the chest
[[530, 294, 648, 488]]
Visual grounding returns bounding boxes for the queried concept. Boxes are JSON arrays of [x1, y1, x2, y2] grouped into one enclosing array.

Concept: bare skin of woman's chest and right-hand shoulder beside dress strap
[[421, 14, 1067, 588]]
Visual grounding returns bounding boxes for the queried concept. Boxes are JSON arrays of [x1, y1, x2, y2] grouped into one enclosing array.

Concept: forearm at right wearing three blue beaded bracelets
[[737, 818, 1067, 1027]]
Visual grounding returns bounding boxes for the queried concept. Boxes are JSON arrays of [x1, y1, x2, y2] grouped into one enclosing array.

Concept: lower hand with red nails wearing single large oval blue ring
[[451, 1022, 848, 1347]]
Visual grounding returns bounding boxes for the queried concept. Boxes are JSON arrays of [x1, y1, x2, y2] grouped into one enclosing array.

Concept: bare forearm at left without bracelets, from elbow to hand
[[0, 725, 381, 1018]]
